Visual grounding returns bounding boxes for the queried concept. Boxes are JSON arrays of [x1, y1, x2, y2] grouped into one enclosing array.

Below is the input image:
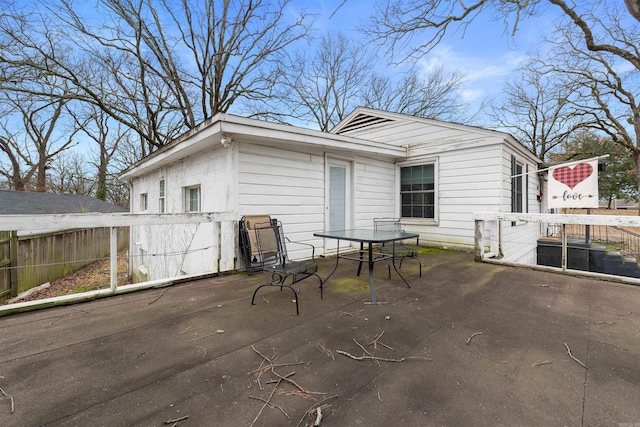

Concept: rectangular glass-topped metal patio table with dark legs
[[313, 229, 419, 304]]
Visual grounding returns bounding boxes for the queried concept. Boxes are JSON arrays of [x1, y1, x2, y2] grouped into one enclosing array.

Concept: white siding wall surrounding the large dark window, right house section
[[345, 119, 540, 263]]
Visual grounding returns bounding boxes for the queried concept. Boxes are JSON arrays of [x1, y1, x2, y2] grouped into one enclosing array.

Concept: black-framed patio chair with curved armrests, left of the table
[[239, 217, 324, 314]]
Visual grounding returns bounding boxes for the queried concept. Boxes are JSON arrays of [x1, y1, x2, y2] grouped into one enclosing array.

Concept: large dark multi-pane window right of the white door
[[400, 163, 436, 219]]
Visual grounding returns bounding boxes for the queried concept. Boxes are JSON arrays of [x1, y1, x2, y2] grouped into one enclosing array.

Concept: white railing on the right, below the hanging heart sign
[[473, 212, 640, 280]]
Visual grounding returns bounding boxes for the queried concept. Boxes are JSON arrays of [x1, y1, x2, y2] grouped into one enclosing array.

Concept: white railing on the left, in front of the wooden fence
[[0, 212, 237, 315]]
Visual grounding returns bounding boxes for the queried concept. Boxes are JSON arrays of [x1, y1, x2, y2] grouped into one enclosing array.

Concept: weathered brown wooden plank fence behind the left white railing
[[0, 227, 129, 299]]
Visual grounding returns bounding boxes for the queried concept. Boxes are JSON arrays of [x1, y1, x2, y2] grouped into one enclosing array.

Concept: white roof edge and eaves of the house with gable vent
[[119, 107, 534, 180]]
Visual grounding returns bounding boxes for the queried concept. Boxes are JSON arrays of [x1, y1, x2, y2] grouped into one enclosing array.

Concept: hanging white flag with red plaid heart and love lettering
[[547, 159, 598, 208]]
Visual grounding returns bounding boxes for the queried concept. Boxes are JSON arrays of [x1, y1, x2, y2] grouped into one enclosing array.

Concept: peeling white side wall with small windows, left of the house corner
[[131, 147, 234, 280]]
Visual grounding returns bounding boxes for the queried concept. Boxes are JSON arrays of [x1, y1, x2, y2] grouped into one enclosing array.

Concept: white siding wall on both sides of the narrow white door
[[238, 144, 395, 258]]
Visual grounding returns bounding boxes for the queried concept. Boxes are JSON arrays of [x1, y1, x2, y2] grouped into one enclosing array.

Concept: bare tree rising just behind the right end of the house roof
[[489, 61, 586, 164]]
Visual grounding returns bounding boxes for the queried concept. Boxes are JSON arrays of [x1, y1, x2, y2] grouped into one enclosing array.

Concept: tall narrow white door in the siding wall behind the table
[[325, 159, 351, 250]]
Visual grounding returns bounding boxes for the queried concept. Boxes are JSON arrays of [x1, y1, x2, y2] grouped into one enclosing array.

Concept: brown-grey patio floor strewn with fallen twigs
[[0, 252, 640, 427]]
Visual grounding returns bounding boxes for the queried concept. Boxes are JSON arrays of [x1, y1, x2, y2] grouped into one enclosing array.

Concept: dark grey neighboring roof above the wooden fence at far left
[[0, 190, 128, 215]]
